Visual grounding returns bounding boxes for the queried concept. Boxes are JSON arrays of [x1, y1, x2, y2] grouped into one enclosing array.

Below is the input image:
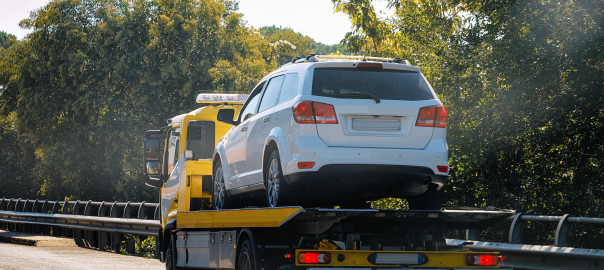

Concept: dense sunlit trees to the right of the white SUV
[[333, 0, 604, 246]]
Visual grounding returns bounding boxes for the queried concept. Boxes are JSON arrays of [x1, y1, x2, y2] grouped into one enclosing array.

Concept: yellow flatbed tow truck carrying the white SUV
[[144, 94, 514, 270]]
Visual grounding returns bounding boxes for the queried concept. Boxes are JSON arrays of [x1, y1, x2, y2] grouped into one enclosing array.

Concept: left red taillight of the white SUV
[[292, 101, 338, 124]]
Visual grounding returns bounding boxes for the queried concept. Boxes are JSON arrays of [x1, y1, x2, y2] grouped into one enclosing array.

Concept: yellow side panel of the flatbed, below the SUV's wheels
[[176, 207, 303, 229]]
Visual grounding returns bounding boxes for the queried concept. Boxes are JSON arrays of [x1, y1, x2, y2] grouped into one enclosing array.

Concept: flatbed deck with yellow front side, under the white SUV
[[176, 207, 515, 229]]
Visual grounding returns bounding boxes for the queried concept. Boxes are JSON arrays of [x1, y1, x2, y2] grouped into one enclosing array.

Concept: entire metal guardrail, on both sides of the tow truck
[[0, 199, 604, 269]]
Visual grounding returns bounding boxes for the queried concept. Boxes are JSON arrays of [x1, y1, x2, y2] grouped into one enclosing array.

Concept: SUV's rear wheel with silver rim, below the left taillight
[[264, 150, 287, 207]]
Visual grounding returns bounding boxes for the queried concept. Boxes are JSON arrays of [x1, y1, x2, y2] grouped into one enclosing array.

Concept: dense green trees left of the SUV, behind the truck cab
[[0, 0, 336, 201]]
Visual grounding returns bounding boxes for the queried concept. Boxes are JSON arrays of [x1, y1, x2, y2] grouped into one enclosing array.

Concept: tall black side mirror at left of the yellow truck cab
[[143, 131, 163, 187]]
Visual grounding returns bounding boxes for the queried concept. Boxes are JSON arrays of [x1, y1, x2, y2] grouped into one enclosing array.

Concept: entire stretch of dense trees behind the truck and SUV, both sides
[[0, 0, 604, 243]]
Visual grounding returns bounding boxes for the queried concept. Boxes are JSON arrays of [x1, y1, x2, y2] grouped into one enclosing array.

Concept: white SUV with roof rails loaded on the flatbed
[[213, 55, 449, 209]]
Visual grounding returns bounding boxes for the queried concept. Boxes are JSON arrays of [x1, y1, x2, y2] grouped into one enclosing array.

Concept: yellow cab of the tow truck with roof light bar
[[145, 94, 247, 226]]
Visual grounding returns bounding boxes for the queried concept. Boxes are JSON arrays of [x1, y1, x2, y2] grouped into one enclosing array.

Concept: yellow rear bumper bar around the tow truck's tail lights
[[295, 249, 499, 269]]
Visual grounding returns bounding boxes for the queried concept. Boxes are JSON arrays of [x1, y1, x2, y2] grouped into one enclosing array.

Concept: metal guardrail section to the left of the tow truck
[[0, 198, 160, 253]]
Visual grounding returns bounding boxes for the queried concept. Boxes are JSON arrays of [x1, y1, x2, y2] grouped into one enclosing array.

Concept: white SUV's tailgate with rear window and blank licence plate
[[312, 63, 440, 149]]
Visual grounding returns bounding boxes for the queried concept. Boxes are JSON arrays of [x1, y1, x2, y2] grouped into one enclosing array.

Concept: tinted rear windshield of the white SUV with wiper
[[312, 68, 436, 100]]
